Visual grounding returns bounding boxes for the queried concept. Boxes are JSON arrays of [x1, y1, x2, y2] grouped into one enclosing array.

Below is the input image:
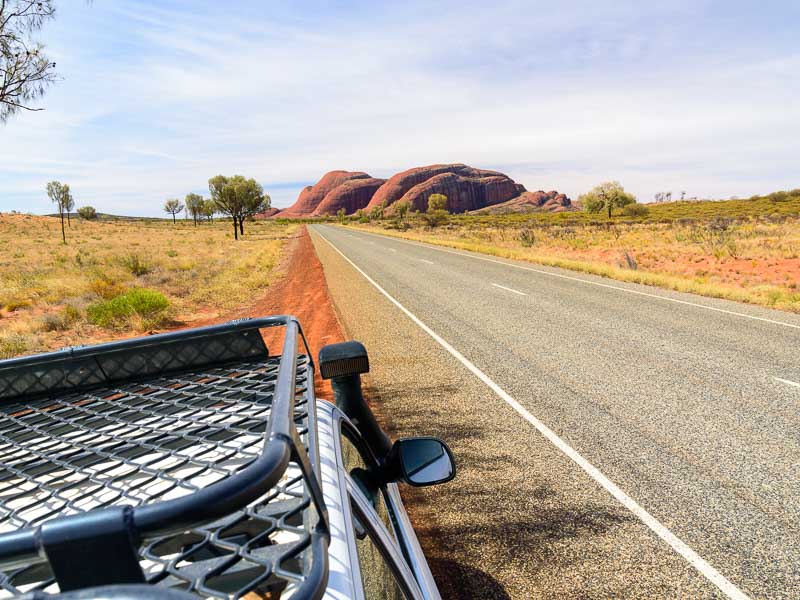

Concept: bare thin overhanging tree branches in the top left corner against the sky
[[0, 0, 56, 123]]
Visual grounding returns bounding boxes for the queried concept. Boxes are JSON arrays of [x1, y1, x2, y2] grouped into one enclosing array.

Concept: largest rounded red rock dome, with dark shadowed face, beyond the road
[[367, 164, 525, 213]]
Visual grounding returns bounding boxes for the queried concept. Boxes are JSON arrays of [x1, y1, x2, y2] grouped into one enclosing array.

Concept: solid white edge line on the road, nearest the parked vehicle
[[320, 226, 747, 600]]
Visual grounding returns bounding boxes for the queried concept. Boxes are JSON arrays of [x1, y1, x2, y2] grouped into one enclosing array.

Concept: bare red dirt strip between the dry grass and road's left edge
[[192, 226, 344, 399]]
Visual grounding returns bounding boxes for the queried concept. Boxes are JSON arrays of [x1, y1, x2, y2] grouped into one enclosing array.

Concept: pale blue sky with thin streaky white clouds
[[0, 0, 800, 215]]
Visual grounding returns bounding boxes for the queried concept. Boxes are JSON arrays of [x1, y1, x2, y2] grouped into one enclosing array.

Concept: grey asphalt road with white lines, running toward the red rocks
[[312, 226, 800, 598]]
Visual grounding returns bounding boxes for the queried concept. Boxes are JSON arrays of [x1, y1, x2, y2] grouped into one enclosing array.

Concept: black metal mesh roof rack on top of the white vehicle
[[0, 316, 330, 598]]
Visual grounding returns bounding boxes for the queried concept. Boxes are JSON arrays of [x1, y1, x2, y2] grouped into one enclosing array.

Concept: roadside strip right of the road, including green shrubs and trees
[[340, 188, 800, 312]]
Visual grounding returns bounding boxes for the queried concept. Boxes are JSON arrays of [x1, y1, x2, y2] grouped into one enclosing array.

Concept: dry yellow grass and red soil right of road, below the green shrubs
[[353, 217, 800, 312]]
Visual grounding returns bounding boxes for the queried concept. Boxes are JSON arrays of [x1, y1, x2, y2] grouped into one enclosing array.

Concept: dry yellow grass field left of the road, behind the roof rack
[[0, 214, 296, 358]]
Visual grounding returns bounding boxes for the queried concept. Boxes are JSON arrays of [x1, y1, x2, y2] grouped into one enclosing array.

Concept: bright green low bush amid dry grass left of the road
[[86, 288, 169, 330]]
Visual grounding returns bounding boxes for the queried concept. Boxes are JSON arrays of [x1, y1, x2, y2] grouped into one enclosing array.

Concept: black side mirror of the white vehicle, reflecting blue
[[387, 437, 456, 487]]
